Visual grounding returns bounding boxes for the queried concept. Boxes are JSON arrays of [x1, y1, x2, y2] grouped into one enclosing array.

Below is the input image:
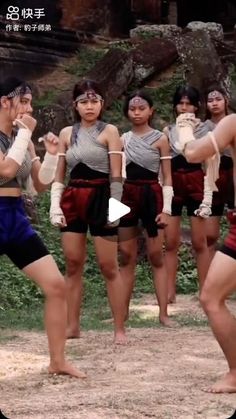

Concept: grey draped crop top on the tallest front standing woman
[[66, 121, 110, 173]]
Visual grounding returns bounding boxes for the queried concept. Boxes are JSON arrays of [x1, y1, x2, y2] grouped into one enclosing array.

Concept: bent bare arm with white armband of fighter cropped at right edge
[[184, 114, 236, 163]]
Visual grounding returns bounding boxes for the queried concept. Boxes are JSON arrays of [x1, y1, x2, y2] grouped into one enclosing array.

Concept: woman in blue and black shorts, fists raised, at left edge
[[0, 78, 85, 378]]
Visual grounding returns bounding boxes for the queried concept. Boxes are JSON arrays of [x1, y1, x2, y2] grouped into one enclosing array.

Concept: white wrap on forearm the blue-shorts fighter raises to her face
[[7, 128, 32, 166]]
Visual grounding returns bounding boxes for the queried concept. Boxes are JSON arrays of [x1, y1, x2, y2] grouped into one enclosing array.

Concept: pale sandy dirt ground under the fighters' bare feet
[[0, 296, 236, 419]]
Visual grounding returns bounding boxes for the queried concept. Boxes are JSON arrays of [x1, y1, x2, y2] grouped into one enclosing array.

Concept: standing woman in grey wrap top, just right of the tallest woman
[[119, 91, 173, 326]]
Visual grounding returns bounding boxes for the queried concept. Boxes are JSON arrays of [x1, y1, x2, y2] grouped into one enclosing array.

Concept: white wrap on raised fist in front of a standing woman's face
[[176, 113, 198, 151]]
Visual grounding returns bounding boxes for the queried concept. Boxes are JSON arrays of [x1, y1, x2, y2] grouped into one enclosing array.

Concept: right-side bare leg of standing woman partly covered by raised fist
[[190, 217, 210, 290]]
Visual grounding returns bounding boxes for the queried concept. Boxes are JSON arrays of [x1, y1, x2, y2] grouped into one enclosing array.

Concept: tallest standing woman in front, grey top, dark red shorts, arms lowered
[[50, 80, 126, 343]]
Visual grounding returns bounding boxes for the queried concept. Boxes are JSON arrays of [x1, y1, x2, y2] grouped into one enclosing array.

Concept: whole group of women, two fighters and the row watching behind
[[0, 75, 236, 392]]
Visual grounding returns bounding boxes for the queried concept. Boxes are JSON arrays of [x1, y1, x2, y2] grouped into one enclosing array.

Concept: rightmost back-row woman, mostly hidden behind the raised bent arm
[[205, 86, 234, 259]]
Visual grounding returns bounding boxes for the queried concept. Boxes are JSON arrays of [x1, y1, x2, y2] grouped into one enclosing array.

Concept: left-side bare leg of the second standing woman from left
[[119, 227, 138, 320]]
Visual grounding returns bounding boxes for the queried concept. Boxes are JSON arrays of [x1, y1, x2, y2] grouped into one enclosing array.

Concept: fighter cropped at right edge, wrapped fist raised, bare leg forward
[[177, 115, 236, 393]]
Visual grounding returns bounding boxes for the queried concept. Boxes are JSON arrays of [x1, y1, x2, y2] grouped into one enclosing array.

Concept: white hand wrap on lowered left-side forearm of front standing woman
[[49, 182, 65, 227]]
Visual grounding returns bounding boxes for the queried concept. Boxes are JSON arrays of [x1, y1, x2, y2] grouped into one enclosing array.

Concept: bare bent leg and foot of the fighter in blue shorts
[[23, 255, 86, 378]]
